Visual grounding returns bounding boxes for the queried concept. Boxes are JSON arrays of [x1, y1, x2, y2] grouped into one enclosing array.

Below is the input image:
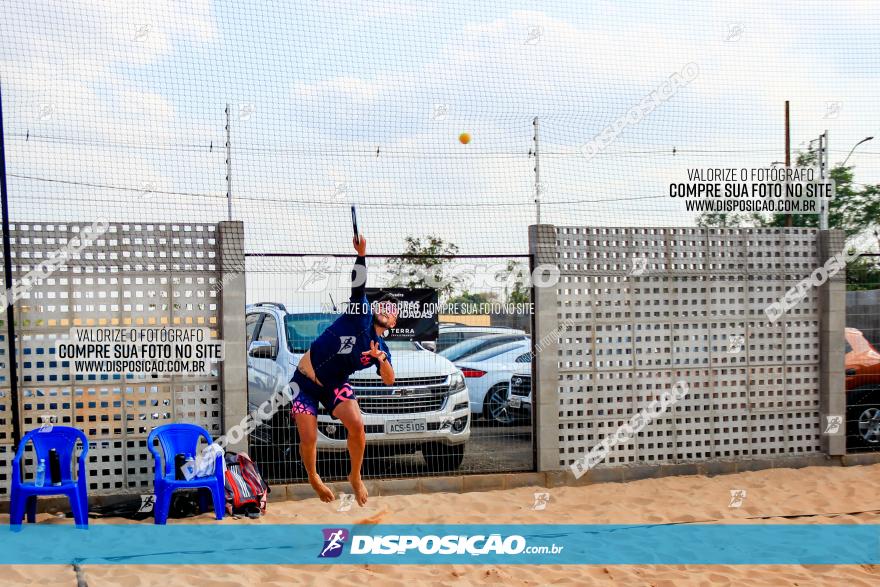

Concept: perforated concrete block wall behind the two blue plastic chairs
[[0, 222, 247, 500]]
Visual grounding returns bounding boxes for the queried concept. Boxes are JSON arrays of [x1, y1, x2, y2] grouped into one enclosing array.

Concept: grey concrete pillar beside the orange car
[[817, 230, 846, 455]]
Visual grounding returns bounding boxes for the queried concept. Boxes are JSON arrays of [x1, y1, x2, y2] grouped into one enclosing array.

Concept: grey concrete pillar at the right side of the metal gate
[[529, 224, 562, 471]]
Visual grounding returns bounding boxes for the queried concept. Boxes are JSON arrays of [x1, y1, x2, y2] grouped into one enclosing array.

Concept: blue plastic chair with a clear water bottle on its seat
[[9, 426, 89, 530]]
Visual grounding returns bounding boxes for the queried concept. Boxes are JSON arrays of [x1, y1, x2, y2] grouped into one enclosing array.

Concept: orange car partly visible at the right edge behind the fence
[[845, 328, 880, 448]]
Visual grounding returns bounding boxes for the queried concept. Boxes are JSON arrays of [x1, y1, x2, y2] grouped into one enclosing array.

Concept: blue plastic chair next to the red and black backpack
[[147, 424, 226, 524]]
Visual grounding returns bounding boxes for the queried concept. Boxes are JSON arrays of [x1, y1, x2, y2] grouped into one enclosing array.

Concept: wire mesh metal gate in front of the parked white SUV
[[247, 254, 534, 482]]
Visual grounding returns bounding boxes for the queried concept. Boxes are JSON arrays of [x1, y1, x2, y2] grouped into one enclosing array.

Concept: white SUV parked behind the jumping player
[[246, 303, 471, 471]]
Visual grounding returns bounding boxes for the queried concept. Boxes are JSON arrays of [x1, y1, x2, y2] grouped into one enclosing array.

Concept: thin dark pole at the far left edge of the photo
[[0, 81, 21, 450]]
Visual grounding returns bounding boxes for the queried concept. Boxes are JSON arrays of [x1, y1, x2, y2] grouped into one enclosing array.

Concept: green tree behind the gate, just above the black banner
[[388, 235, 459, 297]]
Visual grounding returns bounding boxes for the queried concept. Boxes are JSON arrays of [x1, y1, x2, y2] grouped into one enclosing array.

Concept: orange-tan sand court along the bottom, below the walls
[[0, 465, 880, 587]]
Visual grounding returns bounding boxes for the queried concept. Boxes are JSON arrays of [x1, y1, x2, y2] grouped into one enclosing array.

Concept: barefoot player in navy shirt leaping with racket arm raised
[[291, 235, 398, 506]]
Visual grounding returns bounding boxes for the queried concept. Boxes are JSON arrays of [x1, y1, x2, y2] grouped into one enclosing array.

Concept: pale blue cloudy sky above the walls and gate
[[0, 0, 880, 253]]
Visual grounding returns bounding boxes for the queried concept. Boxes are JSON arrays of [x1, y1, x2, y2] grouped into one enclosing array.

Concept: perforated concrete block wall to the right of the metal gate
[[530, 225, 844, 470]]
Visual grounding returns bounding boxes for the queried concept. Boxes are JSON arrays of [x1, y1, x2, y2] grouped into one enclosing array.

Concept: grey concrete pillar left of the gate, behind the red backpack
[[217, 220, 248, 452]]
